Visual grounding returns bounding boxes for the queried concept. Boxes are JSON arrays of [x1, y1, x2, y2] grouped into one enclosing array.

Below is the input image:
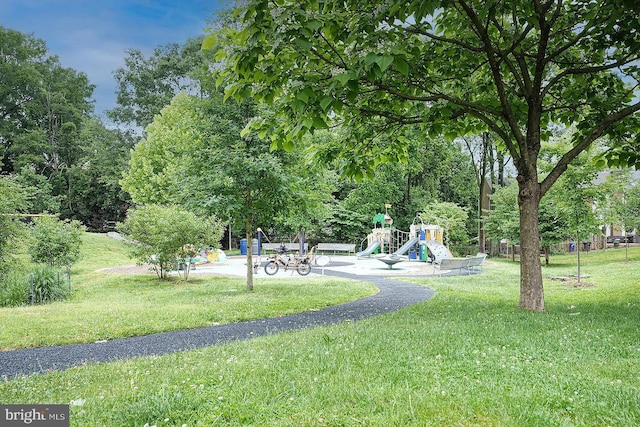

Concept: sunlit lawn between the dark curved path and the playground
[[0, 234, 376, 350]]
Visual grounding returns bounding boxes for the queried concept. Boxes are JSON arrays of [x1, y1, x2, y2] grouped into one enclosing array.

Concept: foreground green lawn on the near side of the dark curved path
[[0, 242, 640, 426]]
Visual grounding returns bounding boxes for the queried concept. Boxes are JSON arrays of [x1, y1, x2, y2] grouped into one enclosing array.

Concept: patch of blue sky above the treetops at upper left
[[0, 0, 230, 120]]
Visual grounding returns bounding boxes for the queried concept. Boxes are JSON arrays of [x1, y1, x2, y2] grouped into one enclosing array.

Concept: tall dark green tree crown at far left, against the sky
[[0, 27, 94, 176]]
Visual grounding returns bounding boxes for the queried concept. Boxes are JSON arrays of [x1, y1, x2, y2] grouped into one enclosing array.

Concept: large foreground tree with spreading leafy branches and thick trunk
[[210, 0, 640, 311]]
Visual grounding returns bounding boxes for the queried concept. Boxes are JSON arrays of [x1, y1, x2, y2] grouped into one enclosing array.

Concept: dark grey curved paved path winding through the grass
[[0, 270, 435, 378]]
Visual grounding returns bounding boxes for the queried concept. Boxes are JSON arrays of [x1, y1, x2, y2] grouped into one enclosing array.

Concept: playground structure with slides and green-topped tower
[[356, 209, 452, 268]]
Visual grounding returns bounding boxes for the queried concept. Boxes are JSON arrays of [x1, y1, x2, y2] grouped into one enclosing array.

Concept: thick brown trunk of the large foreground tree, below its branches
[[518, 177, 545, 311]]
